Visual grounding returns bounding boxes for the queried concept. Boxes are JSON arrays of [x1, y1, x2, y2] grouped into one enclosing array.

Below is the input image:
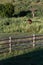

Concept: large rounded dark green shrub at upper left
[[0, 3, 14, 17]]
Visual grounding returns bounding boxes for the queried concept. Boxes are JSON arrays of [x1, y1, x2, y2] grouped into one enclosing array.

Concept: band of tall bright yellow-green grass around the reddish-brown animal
[[0, 17, 43, 34]]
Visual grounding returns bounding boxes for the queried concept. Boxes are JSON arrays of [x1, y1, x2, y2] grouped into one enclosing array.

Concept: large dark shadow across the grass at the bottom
[[0, 49, 43, 65]]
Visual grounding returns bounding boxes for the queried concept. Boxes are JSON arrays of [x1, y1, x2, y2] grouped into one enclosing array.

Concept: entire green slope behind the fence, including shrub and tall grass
[[0, 0, 43, 34]]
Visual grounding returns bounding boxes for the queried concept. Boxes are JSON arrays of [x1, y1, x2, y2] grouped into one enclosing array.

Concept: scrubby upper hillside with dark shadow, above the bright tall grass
[[0, 0, 43, 17]]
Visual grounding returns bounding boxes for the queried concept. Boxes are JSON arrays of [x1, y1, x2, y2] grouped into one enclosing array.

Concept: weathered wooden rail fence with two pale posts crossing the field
[[0, 34, 43, 53]]
